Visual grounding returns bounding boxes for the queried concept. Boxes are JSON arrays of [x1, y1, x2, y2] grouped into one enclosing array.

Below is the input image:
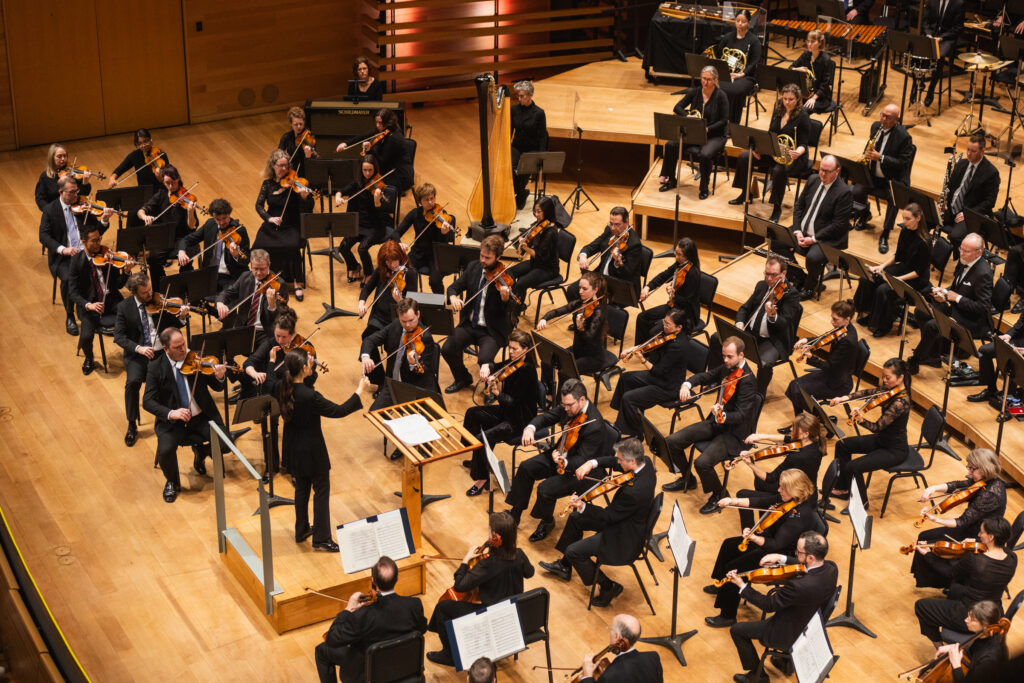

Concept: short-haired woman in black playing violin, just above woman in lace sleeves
[[785, 300, 858, 415]]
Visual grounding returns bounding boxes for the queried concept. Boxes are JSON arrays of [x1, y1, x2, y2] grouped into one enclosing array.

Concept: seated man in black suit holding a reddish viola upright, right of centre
[[662, 337, 758, 515]]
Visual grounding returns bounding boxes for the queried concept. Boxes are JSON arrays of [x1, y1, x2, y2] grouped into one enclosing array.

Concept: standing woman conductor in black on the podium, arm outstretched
[[278, 348, 370, 553]]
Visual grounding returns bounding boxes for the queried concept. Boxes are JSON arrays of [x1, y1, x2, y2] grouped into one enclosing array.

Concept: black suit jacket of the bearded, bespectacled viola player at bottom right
[[739, 557, 839, 650]]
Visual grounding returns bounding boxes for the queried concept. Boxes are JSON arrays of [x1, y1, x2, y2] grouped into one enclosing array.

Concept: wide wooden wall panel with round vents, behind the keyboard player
[[183, 0, 359, 122]]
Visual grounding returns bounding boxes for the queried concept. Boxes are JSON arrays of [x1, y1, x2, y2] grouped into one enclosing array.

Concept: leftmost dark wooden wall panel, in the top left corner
[[3, 0, 104, 146]]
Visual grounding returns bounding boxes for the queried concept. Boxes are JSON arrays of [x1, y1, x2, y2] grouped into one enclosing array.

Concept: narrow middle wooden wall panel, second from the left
[[96, 0, 188, 135]]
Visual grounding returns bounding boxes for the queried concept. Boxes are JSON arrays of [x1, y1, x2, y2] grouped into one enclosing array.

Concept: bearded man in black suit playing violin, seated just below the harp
[[441, 234, 512, 393]]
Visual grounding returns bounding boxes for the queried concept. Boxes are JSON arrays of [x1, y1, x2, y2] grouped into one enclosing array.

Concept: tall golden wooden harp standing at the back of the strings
[[467, 74, 516, 232]]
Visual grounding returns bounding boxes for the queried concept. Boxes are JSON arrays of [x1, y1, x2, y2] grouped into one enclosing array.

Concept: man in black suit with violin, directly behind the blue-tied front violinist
[[114, 272, 181, 447]]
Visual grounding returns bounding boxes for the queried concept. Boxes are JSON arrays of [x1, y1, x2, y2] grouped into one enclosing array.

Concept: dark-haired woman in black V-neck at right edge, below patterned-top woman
[[913, 516, 1017, 650]]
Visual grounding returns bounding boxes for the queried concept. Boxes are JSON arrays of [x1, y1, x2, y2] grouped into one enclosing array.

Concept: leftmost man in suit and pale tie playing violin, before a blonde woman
[[39, 173, 114, 337]]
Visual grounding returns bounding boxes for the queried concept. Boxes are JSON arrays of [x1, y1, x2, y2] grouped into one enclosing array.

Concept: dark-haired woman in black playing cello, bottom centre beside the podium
[[427, 512, 535, 667]]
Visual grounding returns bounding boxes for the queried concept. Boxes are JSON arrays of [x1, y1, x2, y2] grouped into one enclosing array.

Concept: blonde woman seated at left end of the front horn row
[[658, 66, 729, 200]]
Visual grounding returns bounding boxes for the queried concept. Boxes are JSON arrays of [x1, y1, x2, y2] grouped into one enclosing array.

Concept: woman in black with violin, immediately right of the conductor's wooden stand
[[463, 330, 538, 497]]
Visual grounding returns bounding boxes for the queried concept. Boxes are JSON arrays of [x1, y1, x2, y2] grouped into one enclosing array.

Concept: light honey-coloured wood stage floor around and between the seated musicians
[[0, 45, 1024, 681]]
